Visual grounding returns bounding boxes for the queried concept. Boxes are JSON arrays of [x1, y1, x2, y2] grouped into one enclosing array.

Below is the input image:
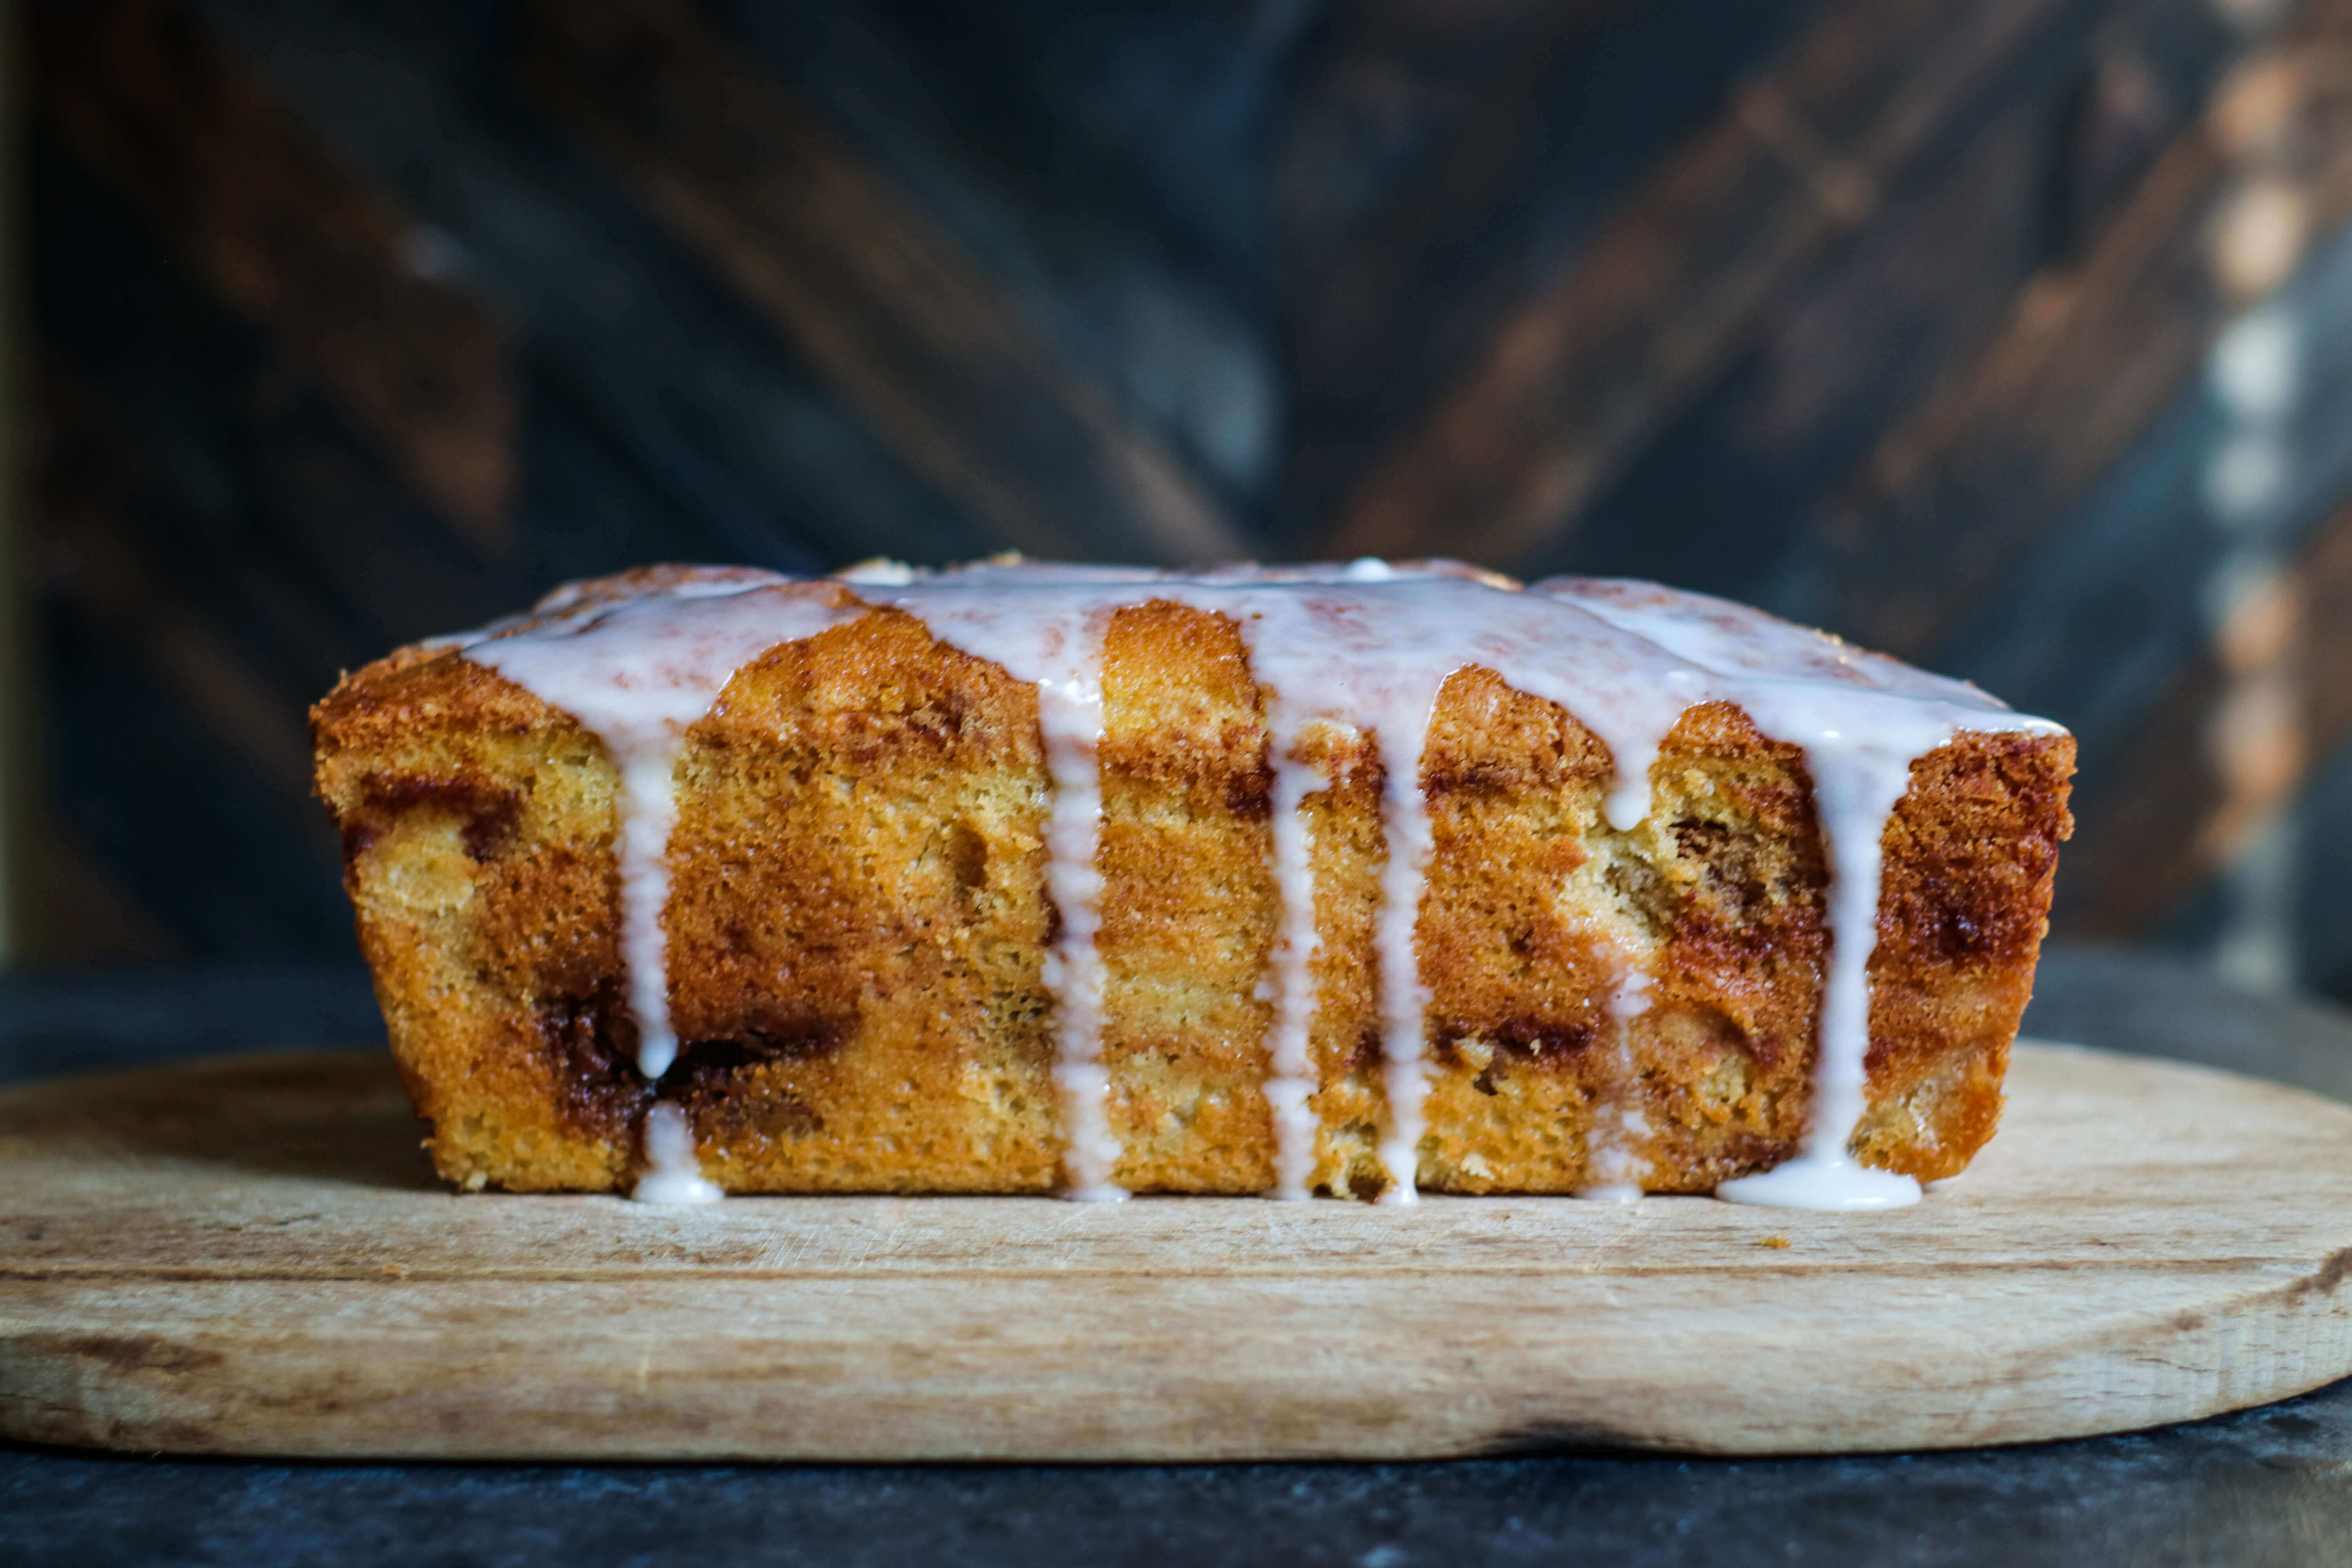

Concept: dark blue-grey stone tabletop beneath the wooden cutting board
[[0, 952, 2352, 1568]]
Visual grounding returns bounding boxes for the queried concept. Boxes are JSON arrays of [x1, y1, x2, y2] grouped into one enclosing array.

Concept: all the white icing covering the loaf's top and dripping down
[[449, 562, 2058, 1208]]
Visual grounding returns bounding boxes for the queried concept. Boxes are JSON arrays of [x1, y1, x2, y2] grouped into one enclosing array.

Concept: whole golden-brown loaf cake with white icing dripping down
[[313, 562, 2072, 1206]]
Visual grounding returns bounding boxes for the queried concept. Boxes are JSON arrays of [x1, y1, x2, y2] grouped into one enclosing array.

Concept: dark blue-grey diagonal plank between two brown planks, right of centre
[[1522, 0, 2239, 616]]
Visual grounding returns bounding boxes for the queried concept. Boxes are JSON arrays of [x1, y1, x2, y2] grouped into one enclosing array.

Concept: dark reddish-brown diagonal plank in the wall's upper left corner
[[35, 0, 515, 552]]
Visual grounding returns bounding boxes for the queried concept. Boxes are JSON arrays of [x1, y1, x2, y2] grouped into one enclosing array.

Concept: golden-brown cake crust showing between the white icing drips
[[313, 604, 2072, 1194]]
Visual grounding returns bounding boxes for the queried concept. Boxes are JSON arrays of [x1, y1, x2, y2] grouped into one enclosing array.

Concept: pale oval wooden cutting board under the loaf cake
[[0, 1046, 2352, 1460]]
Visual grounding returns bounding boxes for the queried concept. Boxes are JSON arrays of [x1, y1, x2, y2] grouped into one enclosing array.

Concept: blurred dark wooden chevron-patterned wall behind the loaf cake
[[16, 0, 2352, 997]]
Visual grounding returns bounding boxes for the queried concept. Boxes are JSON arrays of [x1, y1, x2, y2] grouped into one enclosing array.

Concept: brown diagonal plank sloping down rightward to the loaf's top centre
[[532, 0, 1244, 562]]
